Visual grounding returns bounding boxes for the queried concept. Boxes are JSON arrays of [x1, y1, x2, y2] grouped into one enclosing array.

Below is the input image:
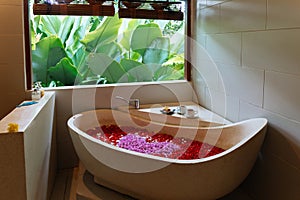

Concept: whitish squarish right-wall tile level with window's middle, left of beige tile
[[206, 33, 241, 65]]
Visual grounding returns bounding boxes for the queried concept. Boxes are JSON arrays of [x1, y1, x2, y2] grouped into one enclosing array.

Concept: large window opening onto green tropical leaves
[[25, 0, 189, 88]]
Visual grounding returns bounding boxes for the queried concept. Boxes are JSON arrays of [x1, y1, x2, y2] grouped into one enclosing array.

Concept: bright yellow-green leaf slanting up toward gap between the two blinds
[[81, 15, 122, 52]]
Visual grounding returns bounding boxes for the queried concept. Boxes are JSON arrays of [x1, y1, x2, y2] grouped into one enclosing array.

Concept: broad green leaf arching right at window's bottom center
[[88, 53, 128, 83]]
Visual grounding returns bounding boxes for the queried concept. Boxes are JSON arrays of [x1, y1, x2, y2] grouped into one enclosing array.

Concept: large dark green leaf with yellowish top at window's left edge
[[32, 36, 67, 83]]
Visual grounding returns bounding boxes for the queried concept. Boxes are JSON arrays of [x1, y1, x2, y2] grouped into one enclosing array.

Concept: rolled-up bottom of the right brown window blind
[[119, 8, 183, 20]]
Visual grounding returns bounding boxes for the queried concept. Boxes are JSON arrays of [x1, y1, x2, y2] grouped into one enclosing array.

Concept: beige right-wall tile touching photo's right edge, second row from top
[[242, 29, 300, 74]]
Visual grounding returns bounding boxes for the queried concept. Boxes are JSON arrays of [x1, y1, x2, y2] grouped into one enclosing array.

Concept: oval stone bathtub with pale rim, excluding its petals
[[68, 109, 267, 200]]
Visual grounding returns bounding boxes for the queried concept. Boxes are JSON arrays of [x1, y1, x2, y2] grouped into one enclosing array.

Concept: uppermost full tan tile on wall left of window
[[0, 4, 23, 35]]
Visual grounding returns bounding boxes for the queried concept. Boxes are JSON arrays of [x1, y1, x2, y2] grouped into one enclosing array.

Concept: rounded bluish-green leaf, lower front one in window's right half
[[143, 37, 170, 64]]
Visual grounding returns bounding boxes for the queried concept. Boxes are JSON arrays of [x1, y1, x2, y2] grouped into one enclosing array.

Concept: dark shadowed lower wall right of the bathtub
[[242, 126, 300, 200]]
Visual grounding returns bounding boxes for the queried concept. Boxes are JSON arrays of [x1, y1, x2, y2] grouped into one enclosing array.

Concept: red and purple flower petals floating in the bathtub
[[86, 125, 224, 160]]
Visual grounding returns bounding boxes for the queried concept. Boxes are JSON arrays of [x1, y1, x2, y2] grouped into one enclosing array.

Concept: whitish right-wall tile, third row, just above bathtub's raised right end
[[218, 64, 264, 106]]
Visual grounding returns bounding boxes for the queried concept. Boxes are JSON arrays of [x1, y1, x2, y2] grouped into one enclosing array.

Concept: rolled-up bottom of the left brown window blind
[[33, 3, 115, 16]]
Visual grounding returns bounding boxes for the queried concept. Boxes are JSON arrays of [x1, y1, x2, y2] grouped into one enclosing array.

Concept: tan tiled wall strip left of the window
[[0, 0, 25, 119]]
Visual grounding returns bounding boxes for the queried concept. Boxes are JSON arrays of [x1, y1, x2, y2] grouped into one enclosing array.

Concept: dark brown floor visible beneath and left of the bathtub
[[50, 167, 252, 200]]
